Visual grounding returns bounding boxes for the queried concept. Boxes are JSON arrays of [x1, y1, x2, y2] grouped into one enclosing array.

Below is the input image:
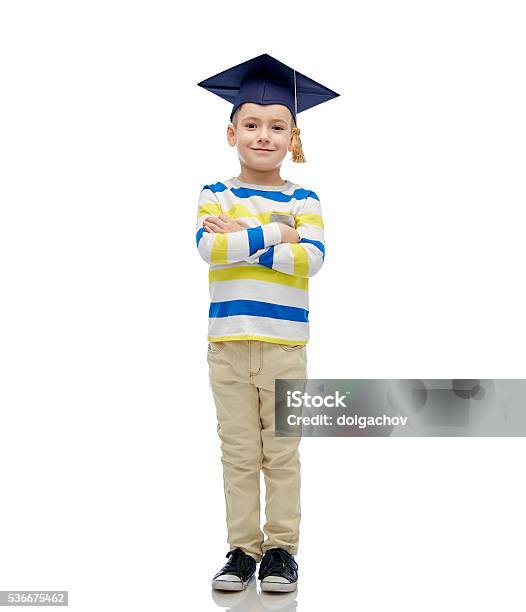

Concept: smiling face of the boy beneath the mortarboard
[[227, 102, 292, 171]]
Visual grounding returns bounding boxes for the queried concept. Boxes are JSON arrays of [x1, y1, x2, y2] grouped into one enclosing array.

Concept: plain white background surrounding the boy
[[0, 0, 526, 612]]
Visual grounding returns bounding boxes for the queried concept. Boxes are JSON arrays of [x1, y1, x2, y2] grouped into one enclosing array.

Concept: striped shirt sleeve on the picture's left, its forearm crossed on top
[[195, 186, 281, 264]]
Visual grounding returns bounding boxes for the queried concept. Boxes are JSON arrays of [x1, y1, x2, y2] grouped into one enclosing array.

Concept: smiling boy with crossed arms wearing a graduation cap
[[196, 54, 338, 592]]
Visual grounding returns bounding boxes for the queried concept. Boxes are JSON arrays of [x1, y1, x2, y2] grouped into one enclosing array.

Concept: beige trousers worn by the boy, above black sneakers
[[208, 340, 307, 561]]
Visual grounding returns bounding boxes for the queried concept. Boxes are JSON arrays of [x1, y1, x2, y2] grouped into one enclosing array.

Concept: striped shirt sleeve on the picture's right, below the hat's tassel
[[246, 191, 325, 278]]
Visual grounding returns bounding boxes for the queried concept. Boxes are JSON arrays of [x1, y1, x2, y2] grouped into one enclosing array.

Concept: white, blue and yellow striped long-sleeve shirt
[[196, 178, 325, 345]]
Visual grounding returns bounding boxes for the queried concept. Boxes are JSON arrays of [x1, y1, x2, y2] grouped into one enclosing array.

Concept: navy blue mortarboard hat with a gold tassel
[[198, 53, 340, 162]]
